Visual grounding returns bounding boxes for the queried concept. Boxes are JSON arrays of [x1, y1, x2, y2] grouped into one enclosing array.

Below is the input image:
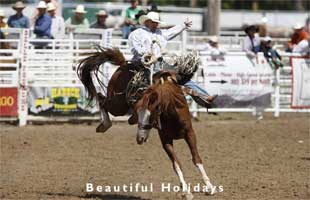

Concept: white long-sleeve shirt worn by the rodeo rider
[[128, 25, 185, 60]]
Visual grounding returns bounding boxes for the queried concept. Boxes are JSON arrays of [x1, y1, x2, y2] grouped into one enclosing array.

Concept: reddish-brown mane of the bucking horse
[[143, 73, 187, 114]]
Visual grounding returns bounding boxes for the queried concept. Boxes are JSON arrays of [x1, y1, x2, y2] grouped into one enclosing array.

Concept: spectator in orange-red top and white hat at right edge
[[287, 23, 309, 54]]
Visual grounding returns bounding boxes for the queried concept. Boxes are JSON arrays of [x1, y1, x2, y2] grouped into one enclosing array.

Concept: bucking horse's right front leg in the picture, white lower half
[[185, 129, 216, 194]]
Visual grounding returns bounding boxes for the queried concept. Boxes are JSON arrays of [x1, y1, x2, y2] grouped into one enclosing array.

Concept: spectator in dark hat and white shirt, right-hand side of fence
[[242, 25, 260, 58]]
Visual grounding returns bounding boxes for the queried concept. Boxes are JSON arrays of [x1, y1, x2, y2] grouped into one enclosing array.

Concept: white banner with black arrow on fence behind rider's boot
[[202, 53, 274, 108]]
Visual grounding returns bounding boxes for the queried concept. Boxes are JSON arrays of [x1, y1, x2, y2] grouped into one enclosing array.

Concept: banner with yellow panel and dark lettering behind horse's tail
[[28, 87, 99, 116]]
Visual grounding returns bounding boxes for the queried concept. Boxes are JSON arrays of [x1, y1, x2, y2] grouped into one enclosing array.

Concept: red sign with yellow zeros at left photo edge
[[0, 88, 18, 117]]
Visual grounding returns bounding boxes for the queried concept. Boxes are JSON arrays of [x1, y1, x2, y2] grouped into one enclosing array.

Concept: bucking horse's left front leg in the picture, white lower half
[[159, 133, 194, 200]]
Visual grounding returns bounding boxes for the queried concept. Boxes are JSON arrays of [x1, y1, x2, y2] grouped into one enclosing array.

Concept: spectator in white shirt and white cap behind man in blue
[[47, 3, 65, 39]]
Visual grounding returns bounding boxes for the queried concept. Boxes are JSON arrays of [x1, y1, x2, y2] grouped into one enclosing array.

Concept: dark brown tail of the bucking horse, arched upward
[[77, 46, 126, 101]]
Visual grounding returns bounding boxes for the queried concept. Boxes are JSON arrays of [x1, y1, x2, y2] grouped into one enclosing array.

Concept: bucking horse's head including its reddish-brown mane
[[135, 72, 187, 144]]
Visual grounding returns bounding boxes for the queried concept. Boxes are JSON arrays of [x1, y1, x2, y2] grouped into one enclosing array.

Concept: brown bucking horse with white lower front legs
[[78, 48, 217, 200]]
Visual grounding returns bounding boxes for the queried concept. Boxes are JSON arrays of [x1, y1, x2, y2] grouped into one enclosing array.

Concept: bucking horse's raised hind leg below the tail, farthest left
[[96, 93, 112, 133]]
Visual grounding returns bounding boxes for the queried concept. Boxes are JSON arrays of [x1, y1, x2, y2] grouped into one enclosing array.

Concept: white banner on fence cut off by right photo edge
[[291, 57, 310, 108]]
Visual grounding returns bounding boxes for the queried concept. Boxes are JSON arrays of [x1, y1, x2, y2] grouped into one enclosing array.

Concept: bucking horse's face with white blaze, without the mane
[[135, 87, 160, 144]]
